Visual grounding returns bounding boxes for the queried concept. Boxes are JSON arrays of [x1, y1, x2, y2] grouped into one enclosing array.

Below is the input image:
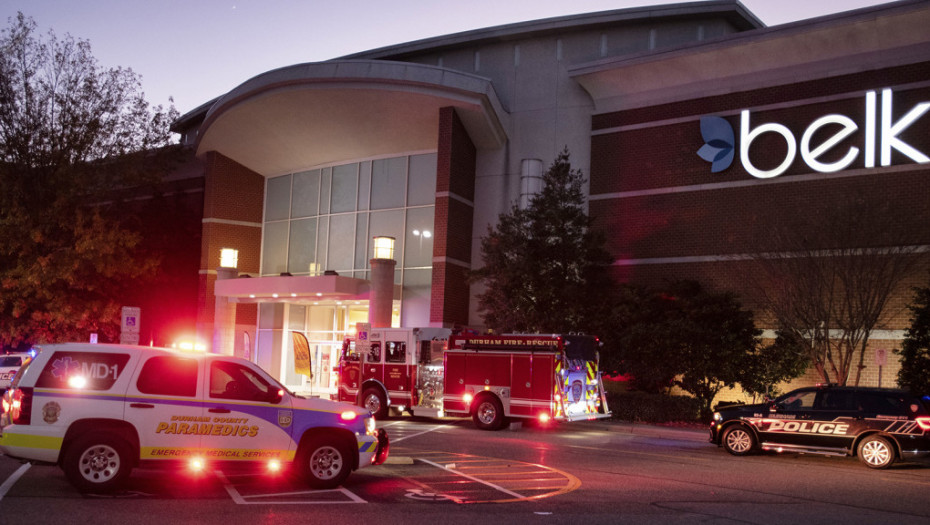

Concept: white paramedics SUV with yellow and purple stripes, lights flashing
[[0, 343, 389, 492]]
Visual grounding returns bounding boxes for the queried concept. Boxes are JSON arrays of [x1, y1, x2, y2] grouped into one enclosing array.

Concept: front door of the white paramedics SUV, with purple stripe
[[201, 358, 296, 461]]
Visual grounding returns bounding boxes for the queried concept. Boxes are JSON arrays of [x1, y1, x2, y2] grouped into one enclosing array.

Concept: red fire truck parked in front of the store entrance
[[336, 328, 610, 430]]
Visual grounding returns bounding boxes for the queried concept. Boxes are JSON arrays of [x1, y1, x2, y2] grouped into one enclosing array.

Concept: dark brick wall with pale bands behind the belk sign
[[590, 62, 930, 386]]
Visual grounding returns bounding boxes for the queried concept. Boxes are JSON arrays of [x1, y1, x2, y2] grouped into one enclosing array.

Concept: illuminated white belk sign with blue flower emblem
[[697, 89, 930, 179]]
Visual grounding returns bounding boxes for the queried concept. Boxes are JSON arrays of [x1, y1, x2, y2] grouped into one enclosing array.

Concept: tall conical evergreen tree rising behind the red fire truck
[[472, 149, 612, 333]]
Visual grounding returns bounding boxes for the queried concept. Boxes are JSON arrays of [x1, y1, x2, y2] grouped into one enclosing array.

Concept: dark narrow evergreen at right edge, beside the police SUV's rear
[[895, 278, 930, 394]]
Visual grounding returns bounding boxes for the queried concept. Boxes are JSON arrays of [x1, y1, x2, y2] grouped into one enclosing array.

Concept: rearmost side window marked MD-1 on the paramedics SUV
[[36, 351, 129, 390]]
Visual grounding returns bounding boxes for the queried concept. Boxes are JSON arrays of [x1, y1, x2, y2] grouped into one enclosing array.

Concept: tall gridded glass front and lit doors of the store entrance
[[256, 153, 436, 393]]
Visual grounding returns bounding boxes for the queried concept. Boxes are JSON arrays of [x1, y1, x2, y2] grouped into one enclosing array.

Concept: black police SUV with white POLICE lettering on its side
[[710, 386, 930, 469]]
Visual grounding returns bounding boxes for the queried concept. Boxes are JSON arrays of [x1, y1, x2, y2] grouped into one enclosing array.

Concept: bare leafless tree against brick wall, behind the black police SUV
[[752, 189, 920, 385]]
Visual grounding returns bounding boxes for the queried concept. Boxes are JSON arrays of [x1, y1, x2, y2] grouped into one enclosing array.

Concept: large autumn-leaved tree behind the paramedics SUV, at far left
[[0, 13, 177, 347]]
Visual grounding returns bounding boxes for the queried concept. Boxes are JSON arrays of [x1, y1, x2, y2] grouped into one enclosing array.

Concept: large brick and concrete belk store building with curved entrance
[[175, 0, 930, 393]]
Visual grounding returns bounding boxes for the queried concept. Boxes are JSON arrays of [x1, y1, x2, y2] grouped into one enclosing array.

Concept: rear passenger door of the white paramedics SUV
[[125, 354, 204, 460]]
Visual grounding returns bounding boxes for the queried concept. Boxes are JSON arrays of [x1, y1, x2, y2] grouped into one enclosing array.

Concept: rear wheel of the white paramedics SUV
[[62, 433, 132, 492]]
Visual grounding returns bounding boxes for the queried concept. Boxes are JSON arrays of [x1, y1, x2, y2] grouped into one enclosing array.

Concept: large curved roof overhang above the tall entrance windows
[[191, 60, 509, 177]]
